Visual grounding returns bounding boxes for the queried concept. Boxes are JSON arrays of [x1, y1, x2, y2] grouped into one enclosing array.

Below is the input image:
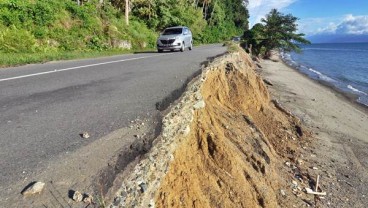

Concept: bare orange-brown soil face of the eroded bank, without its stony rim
[[155, 50, 310, 207]]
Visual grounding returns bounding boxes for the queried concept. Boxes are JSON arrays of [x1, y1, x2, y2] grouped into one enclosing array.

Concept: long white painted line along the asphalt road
[[0, 53, 172, 82]]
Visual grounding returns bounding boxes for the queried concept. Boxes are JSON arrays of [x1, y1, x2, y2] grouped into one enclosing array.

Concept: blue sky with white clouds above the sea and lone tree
[[248, 0, 368, 42]]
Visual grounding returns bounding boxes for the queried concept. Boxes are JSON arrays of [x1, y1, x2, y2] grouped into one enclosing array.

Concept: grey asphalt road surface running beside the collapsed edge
[[0, 45, 226, 193]]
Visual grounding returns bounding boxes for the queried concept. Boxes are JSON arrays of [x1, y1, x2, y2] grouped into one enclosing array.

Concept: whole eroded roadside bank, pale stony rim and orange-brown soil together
[[112, 48, 308, 208]]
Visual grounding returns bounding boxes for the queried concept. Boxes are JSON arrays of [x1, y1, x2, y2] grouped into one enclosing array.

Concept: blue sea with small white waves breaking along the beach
[[281, 43, 368, 107]]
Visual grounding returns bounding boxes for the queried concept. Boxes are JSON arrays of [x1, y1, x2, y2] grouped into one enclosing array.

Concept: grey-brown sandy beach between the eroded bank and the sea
[[260, 56, 368, 207]]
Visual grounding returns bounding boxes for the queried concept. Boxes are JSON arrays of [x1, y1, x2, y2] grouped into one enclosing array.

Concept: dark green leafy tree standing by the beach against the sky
[[244, 9, 310, 58]]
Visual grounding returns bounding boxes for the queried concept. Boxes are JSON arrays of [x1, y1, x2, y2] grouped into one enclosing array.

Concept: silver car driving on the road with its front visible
[[157, 26, 193, 53]]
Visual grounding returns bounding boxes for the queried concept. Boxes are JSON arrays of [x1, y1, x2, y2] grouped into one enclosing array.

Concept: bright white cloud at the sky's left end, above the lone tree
[[248, 0, 297, 26]]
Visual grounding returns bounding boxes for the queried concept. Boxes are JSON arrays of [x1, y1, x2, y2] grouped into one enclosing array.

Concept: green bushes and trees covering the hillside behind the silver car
[[0, 0, 248, 66]]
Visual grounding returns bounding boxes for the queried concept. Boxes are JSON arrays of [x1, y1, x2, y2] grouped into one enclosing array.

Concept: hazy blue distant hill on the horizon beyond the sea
[[307, 34, 368, 43]]
